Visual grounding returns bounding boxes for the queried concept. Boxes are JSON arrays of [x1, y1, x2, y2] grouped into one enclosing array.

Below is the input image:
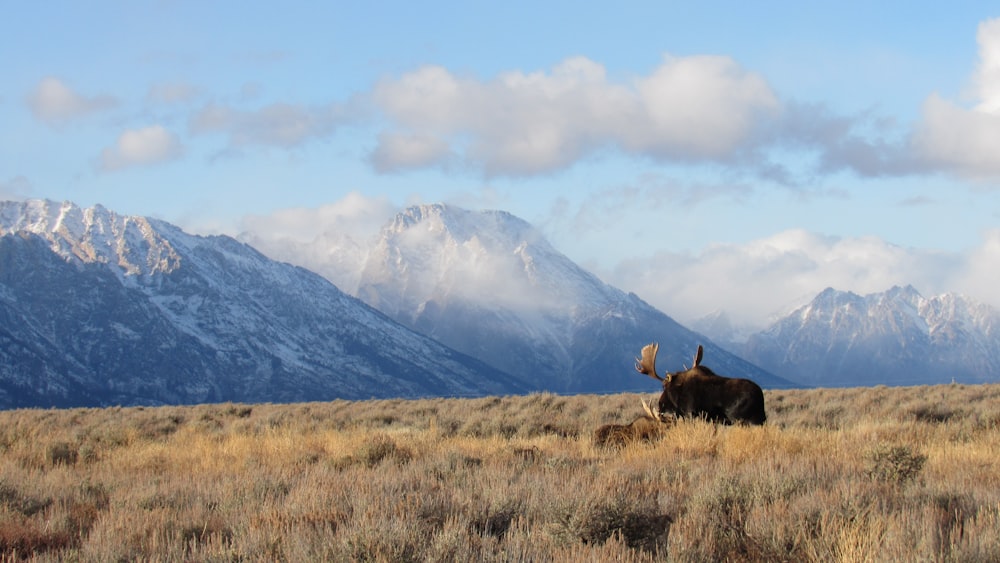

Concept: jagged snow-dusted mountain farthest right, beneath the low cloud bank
[[741, 286, 1000, 387]]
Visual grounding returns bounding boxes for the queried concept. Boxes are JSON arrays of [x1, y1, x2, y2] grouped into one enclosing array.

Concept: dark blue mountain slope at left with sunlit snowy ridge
[[0, 200, 530, 408]]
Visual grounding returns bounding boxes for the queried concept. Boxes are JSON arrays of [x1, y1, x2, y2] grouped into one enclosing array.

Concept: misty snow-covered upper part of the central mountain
[[359, 204, 620, 320]]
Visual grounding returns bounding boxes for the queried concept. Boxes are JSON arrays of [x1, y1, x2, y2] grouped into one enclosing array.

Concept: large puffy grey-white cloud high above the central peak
[[373, 56, 781, 175]]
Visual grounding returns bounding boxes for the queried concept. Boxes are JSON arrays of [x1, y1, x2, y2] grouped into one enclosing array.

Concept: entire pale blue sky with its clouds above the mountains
[[0, 0, 1000, 322]]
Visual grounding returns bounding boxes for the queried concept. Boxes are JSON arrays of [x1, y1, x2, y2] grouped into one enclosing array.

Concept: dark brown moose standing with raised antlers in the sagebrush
[[635, 343, 767, 424]]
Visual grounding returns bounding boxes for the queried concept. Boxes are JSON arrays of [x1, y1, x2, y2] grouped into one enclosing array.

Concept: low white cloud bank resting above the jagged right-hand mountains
[[602, 229, 972, 326]]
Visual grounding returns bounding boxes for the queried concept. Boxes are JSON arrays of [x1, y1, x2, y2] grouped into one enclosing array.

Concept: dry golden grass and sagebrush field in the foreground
[[0, 385, 1000, 561]]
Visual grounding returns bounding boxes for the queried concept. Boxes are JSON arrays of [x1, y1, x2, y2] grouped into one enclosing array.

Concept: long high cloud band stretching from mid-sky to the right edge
[[370, 19, 1000, 184]]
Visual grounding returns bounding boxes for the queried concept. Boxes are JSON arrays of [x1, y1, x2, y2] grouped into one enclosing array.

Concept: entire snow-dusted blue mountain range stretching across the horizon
[[0, 200, 1000, 408]]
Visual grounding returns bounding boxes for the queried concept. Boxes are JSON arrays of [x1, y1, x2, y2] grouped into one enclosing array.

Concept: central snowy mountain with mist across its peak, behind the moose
[[292, 205, 795, 392]]
